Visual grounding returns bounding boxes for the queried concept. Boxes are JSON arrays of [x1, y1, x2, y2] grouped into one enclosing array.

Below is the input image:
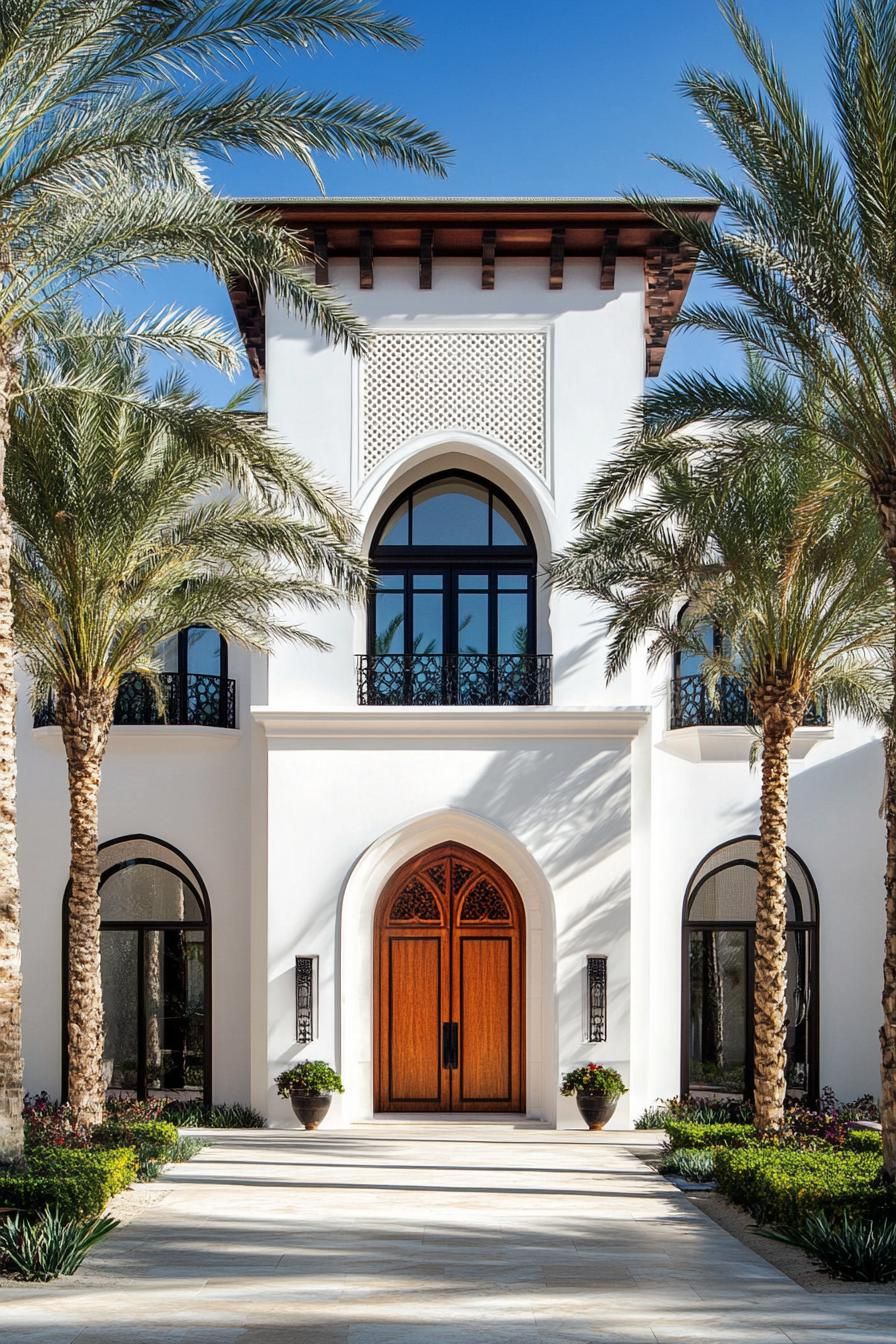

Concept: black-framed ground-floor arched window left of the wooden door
[[63, 836, 211, 1102]]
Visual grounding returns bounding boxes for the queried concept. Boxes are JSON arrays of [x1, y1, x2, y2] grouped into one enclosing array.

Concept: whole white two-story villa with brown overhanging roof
[[19, 198, 884, 1126]]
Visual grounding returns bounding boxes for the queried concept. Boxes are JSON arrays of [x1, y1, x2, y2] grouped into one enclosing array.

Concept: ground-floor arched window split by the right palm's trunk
[[681, 836, 818, 1097]]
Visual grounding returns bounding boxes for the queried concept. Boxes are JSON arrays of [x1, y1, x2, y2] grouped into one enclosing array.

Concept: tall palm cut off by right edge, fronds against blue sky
[[585, 0, 896, 1180]]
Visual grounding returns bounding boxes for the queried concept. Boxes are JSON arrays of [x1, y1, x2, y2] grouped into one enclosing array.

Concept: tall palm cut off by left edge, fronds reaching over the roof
[[0, 0, 447, 1161]]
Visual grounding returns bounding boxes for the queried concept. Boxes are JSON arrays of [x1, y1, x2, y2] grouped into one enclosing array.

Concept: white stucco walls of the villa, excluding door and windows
[[19, 198, 884, 1126]]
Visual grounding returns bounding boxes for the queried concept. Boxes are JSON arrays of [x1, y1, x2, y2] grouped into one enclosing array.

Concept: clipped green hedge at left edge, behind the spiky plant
[[0, 1148, 137, 1219]]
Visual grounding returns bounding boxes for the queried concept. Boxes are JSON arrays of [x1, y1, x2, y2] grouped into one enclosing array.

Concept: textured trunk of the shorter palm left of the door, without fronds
[[56, 689, 114, 1125]]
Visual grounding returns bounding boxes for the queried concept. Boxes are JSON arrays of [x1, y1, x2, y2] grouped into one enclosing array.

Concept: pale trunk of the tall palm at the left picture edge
[[0, 341, 24, 1163]]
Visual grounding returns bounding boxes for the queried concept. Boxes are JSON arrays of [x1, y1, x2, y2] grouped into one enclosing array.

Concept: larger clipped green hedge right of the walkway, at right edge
[[716, 1144, 896, 1224]]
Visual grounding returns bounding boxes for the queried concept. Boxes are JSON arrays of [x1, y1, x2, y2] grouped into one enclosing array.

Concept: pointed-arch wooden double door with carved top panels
[[373, 844, 525, 1111]]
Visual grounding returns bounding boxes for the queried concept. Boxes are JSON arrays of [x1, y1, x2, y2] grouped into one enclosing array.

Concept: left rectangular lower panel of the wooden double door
[[388, 934, 445, 1110]]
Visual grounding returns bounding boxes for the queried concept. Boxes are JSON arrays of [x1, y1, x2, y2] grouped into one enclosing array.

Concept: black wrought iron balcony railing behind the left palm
[[34, 672, 236, 728]]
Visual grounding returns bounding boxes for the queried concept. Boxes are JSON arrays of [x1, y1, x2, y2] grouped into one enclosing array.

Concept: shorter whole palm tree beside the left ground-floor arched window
[[7, 330, 365, 1124]]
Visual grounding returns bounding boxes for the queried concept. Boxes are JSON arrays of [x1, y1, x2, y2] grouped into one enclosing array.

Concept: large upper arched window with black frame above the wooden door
[[359, 470, 551, 704]]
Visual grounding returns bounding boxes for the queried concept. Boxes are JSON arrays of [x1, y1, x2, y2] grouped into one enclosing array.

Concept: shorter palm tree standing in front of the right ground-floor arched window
[[553, 395, 892, 1134]]
